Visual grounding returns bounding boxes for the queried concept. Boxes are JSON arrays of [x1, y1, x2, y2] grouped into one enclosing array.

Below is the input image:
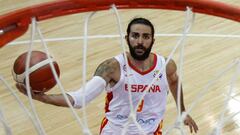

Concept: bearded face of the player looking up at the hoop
[[126, 24, 154, 61]]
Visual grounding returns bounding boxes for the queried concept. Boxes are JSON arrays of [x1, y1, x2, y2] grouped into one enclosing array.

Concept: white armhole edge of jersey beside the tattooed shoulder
[[107, 54, 124, 92]]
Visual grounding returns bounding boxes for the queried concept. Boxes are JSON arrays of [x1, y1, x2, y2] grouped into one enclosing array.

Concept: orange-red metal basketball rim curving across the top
[[0, 0, 240, 134]]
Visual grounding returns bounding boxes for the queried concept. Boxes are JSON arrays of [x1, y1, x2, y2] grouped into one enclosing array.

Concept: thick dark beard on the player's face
[[127, 40, 153, 61]]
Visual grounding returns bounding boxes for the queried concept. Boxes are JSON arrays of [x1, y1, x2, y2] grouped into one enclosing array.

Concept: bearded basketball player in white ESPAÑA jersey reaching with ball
[[17, 18, 198, 135]]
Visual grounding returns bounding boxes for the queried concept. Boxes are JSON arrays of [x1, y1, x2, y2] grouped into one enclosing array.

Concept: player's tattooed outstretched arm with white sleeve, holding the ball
[[16, 58, 119, 108]]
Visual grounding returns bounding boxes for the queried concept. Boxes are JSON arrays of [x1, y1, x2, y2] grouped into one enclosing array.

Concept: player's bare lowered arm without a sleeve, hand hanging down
[[166, 60, 198, 133]]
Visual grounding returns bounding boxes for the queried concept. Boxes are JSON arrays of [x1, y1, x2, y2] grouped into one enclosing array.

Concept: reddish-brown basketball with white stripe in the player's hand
[[12, 51, 60, 92]]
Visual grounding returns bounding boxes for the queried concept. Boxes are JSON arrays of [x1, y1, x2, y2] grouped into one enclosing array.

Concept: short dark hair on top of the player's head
[[127, 17, 154, 37]]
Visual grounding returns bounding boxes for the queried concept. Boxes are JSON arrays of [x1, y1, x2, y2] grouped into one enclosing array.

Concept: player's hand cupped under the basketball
[[16, 83, 46, 101]]
